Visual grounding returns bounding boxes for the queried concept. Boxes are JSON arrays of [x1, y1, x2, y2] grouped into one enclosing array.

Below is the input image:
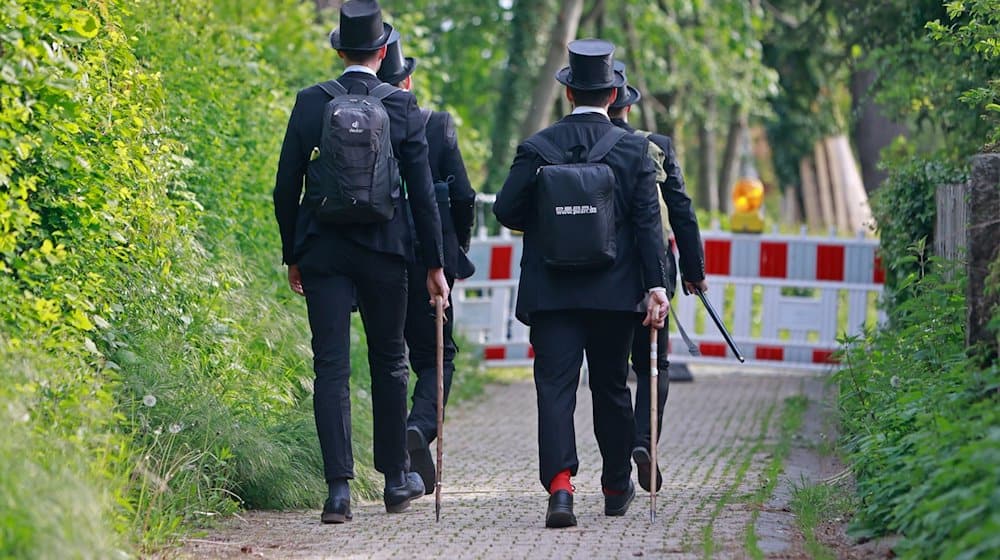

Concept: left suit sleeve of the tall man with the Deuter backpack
[[272, 93, 309, 265]]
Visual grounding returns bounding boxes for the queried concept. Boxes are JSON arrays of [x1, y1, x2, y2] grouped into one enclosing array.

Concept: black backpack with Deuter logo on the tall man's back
[[306, 80, 400, 224]]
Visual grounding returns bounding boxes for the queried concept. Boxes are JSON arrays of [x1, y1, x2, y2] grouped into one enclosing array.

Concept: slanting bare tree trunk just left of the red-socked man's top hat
[[521, 0, 583, 138]]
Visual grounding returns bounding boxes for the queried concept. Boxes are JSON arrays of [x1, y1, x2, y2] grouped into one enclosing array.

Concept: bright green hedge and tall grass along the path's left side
[[0, 0, 484, 558]]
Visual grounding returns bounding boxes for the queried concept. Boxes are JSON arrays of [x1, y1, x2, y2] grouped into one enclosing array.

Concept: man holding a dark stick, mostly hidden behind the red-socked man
[[608, 62, 708, 492]]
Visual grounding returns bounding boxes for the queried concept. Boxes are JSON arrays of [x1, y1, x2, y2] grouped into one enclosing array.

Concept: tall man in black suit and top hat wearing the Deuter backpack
[[274, 0, 448, 523]]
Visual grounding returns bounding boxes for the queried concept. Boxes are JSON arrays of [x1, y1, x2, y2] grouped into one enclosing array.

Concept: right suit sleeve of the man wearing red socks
[[631, 144, 667, 290]]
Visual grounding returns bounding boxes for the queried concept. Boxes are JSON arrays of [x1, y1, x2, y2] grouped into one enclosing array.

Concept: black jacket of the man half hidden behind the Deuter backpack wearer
[[425, 109, 476, 278]]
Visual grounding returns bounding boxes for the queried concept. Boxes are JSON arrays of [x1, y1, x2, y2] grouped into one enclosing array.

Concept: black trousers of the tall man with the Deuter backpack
[[299, 240, 409, 482]]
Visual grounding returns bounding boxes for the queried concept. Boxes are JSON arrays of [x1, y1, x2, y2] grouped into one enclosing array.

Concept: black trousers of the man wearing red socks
[[531, 310, 635, 490]]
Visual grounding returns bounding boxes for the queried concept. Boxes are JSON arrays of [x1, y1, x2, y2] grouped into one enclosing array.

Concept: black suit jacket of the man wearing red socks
[[493, 113, 666, 324]]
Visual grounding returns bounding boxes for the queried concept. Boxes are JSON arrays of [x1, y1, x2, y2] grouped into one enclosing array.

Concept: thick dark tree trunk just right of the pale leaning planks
[[850, 70, 907, 193]]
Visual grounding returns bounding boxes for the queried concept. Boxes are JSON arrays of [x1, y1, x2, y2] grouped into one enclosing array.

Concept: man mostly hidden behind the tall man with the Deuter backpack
[[378, 36, 476, 494]]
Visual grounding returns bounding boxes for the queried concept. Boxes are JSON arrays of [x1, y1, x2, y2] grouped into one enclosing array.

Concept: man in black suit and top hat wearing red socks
[[493, 39, 669, 527]]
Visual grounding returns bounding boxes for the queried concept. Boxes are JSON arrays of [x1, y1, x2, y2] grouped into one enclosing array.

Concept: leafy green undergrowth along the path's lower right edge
[[836, 259, 1000, 559]]
